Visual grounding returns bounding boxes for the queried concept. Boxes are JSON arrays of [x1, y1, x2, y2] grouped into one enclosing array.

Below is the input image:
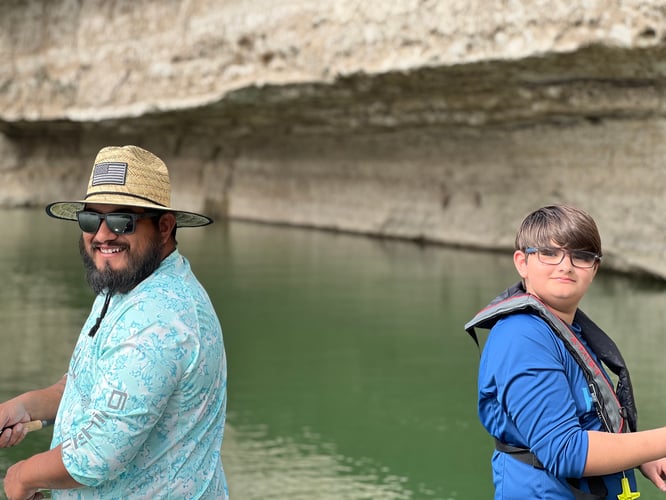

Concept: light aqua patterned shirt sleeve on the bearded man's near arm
[[62, 308, 197, 486]]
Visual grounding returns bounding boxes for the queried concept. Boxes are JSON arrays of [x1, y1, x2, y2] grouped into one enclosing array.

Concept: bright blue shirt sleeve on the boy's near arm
[[479, 314, 588, 477]]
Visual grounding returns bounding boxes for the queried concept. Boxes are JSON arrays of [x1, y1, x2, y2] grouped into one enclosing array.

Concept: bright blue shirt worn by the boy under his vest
[[478, 313, 636, 500]]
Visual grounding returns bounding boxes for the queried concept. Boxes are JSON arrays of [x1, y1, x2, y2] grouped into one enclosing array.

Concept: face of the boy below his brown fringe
[[513, 242, 599, 323]]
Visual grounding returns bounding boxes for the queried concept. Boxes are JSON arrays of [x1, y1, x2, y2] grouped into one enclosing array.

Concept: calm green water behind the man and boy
[[0, 210, 666, 500]]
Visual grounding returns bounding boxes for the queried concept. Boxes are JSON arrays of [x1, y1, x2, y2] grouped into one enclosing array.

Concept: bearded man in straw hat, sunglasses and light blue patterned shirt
[[0, 146, 228, 500]]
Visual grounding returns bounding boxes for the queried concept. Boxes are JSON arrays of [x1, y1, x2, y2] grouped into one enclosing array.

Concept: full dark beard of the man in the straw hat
[[79, 235, 162, 295]]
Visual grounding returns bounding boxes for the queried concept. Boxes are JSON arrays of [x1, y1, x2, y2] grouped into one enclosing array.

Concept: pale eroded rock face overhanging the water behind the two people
[[0, 0, 666, 277]]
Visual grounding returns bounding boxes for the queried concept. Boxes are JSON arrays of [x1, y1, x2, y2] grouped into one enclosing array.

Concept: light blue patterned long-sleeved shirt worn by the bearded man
[[51, 251, 228, 500]]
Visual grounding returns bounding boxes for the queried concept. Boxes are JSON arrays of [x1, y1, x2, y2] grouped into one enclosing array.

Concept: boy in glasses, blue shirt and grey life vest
[[465, 205, 666, 499]]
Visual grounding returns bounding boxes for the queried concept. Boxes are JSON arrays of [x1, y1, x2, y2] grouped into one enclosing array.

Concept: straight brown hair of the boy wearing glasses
[[515, 205, 602, 257]]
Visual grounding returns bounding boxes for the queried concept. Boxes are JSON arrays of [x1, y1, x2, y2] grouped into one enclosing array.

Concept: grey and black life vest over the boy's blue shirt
[[465, 282, 637, 433]]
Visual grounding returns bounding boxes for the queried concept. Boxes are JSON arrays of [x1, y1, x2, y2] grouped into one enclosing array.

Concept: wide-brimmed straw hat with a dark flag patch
[[46, 146, 213, 227]]
